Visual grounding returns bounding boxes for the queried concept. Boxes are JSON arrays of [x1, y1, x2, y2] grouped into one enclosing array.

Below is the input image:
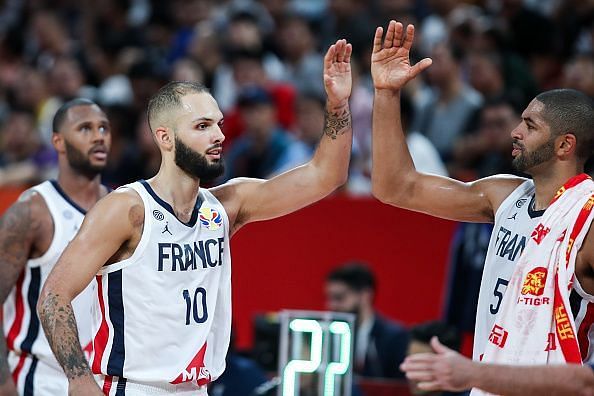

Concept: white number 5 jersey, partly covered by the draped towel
[[473, 180, 544, 361]]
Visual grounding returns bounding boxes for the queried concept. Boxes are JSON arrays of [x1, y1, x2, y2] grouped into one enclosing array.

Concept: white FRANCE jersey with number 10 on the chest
[[91, 181, 231, 394]]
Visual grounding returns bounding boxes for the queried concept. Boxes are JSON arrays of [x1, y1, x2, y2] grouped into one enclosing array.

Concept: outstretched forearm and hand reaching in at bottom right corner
[[401, 337, 594, 396]]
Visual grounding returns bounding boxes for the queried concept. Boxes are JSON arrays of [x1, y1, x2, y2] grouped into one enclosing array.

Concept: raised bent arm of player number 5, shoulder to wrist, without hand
[[371, 90, 524, 222]]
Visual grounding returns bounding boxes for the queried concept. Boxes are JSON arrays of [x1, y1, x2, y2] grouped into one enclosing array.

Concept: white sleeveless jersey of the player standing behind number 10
[[3, 181, 94, 386]]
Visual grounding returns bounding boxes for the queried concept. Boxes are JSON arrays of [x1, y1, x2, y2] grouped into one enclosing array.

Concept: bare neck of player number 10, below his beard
[[148, 161, 200, 221]]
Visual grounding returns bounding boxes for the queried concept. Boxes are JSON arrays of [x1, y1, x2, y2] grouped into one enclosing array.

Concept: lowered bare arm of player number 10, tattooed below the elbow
[[37, 191, 144, 394]]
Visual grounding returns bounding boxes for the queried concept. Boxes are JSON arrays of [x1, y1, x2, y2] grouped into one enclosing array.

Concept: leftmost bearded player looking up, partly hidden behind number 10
[[0, 99, 111, 396]]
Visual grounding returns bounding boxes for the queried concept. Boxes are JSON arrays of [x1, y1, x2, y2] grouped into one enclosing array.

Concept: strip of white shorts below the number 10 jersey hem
[[95, 375, 208, 396]]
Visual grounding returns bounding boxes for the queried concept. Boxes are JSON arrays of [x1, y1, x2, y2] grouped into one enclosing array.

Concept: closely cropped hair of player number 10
[[147, 81, 209, 132]]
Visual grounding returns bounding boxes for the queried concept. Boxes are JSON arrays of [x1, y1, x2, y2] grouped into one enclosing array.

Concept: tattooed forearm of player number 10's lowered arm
[[39, 293, 91, 380]]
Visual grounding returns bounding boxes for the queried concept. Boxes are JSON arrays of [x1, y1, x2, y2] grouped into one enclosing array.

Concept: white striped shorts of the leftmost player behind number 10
[[8, 351, 68, 396]]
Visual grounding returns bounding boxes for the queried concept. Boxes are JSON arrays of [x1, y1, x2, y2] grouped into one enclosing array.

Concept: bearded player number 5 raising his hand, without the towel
[[371, 21, 594, 360]]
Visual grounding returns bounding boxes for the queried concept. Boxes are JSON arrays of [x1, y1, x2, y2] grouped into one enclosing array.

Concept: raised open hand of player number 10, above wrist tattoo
[[324, 40, 353, 107]]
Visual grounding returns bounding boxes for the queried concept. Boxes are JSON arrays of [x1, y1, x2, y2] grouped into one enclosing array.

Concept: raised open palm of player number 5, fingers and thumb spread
[[371, 21, 432, 90]]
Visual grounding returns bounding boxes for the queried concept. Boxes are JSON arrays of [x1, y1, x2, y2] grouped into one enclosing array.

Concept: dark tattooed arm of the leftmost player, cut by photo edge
[[0, 191, 47, 396]]
